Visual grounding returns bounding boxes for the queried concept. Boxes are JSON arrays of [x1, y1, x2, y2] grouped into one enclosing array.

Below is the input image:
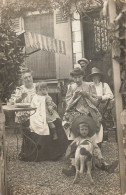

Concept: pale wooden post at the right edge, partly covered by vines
[[108, 0, 126, 195]]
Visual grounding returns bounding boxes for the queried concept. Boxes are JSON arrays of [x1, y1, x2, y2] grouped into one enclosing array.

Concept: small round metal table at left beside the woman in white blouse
[[2, 105, 36, 158]]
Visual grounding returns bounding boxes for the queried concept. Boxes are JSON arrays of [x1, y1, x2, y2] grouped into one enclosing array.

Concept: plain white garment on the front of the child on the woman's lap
[[30, 94, 50, 135]]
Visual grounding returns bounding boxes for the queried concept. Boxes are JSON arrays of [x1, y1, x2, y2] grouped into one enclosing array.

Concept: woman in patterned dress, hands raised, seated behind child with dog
[[63, 68, 102, 143]]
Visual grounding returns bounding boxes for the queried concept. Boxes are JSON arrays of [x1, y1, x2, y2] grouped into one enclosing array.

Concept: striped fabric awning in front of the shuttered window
[[24, 32, 66, 55]]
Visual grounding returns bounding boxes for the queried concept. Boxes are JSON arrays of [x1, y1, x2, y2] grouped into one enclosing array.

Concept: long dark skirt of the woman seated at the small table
[[19, 119, 68, 162]]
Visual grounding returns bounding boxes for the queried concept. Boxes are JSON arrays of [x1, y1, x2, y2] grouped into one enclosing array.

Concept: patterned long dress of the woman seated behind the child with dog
[[63, 82, 102, 143]]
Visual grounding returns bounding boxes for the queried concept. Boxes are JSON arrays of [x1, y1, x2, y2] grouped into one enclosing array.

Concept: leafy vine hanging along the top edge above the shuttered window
[[2, 0, 102, 19]]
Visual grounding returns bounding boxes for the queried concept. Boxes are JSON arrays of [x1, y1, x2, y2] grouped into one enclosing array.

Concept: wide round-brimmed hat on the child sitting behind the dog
[[71, 115, 97, 137]]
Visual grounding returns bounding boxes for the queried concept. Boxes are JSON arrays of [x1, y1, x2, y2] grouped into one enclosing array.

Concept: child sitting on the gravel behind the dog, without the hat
[[62, 121, 118, 176]]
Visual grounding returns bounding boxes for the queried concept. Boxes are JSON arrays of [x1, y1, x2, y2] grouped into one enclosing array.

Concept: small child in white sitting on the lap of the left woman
[[30, 82, 60, 140]]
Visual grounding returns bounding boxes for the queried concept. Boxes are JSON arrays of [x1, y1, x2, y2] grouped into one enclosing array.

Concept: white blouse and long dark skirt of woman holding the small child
[[12, 86, 68, 162]]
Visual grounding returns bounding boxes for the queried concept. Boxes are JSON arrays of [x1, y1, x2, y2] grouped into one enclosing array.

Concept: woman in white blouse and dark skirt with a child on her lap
[[10, 71, 68, 161]]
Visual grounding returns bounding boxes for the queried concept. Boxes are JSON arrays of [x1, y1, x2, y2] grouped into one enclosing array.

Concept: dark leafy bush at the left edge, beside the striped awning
[[0, 22, 24, 100]]
